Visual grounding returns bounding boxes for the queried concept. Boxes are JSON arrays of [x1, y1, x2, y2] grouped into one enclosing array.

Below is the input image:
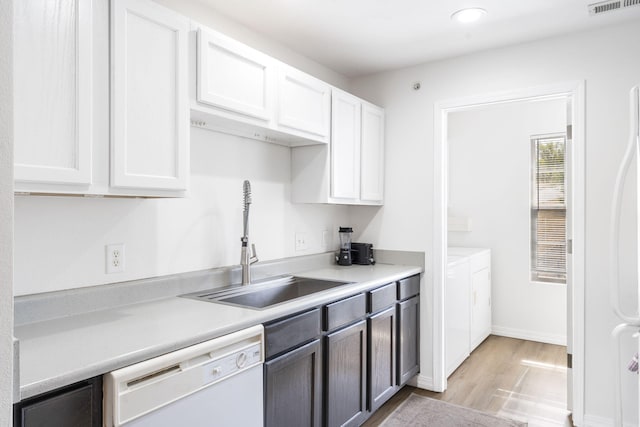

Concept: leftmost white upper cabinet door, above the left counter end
[[14, 0, 93, 189]]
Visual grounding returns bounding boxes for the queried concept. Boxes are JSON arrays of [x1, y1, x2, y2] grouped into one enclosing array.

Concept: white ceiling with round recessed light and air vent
[[195, 0, 640, 77]]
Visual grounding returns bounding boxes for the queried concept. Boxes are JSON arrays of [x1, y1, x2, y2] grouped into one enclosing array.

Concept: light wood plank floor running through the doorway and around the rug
[[364, 335, 572, 427]]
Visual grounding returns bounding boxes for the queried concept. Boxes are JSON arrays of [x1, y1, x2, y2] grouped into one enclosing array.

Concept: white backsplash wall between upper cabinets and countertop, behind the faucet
[[15, 128, 347, 295]]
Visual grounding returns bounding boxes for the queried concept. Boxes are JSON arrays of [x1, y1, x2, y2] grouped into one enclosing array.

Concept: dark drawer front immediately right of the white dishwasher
[[264, 308, 321, 359]]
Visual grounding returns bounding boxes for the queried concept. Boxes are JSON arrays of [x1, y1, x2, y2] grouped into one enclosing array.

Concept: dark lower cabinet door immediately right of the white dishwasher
[[264, 339, 322, 427]]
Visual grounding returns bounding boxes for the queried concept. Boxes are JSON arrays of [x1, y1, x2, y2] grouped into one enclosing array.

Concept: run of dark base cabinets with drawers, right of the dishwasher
[[264, 275, 420, 427]]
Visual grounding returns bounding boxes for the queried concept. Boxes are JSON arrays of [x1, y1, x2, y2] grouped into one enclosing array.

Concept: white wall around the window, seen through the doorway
[[447, 99, 567, 344]]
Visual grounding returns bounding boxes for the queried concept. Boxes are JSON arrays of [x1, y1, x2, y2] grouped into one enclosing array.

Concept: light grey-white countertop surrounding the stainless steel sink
[[15, 264, 422, 399]]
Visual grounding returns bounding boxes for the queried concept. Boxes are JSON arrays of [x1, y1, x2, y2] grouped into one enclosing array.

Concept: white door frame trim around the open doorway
[[433, 82, 584, 423]]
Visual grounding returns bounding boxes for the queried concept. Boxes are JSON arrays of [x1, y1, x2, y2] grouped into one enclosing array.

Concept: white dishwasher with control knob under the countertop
[[104, 325, 264, 427]]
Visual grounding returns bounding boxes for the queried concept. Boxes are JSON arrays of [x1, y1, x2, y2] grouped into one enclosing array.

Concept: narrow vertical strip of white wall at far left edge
[[0, 1, 13, 427]]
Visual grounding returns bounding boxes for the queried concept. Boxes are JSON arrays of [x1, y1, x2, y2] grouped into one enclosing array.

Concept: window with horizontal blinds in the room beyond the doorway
[[531, 135, 567, 283]]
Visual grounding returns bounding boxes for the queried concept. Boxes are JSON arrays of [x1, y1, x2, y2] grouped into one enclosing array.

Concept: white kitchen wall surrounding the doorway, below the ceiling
[[352, 21, 640, 420]]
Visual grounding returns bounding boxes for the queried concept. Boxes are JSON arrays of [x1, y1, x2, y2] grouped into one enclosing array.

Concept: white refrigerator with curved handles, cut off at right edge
[[609, 86, 640, 427]]
